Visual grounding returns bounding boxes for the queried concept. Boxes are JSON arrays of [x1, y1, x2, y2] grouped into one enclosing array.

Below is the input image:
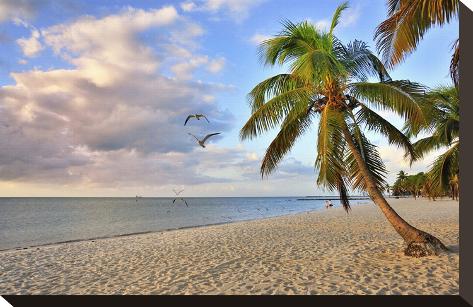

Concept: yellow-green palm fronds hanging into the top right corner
[[375, 0, 460, 85]]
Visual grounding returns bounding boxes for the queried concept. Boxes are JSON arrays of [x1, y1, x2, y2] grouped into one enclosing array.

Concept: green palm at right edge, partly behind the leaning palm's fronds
[[405, 86, 460, 200]]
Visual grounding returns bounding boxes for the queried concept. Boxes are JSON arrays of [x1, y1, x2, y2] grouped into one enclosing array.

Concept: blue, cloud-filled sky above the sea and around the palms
[[0, 0, 458, 197]]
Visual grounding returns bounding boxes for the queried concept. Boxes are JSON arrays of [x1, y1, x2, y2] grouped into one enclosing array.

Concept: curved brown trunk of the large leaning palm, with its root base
[[342, 126, 448, 257]]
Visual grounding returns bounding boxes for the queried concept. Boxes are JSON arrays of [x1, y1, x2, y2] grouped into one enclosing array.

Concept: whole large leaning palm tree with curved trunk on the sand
[[240, 3, 446, 256]]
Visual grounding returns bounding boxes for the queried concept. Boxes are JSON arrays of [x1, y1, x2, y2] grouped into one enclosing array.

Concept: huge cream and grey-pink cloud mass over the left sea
[[0, 7, 239, 187]]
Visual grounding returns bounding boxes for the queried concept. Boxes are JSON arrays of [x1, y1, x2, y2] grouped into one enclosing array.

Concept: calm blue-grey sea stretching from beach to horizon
[[0, 197, 368, 250]]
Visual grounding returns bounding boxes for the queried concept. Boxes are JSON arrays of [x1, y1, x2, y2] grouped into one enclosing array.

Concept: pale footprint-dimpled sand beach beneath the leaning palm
[[0, 199, 459, 294]]
